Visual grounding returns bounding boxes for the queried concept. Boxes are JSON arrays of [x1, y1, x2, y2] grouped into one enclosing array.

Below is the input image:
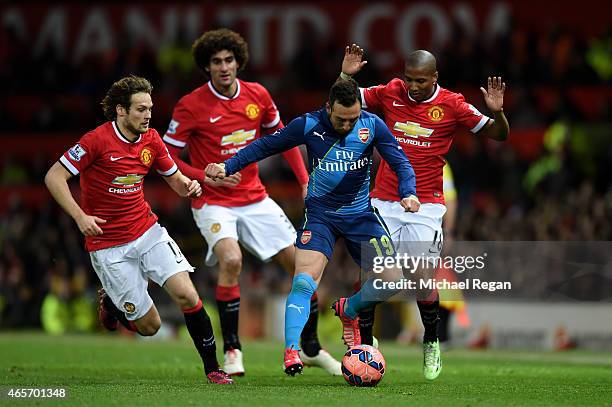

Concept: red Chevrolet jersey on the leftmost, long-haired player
[[60, 122, 178, 251]]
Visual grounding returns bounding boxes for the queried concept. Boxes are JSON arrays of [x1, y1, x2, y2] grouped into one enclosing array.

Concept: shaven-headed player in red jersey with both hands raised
[[340, 44, 510, 380]]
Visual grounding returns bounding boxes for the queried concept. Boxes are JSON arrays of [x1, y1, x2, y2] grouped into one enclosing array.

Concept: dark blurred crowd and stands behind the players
[[0, 1, 612, 331]]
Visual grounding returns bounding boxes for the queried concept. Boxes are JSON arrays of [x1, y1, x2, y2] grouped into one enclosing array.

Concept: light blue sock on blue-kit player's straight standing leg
[[285, 273, 317, 349]]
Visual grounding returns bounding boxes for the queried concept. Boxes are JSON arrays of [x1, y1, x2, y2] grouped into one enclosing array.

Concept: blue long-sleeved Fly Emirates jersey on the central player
[[225, 109, 416, 215]]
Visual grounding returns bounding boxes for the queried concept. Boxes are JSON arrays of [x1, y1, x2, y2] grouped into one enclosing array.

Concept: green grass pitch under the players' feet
[[0, 333, 612, 407]]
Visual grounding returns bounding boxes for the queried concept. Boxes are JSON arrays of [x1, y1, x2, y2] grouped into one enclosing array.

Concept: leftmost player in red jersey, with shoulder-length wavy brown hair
[[45, 76, 233, 384]]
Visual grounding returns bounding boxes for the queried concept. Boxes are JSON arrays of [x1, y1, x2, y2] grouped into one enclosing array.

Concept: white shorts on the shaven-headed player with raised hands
[[372, 198, 446, 257]]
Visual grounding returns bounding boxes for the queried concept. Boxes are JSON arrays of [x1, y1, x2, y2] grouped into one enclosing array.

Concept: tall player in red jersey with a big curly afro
[[164, 29, 342, 375]]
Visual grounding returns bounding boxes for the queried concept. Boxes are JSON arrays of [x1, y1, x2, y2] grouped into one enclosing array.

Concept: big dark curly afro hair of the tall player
[[191, 28, 249, 76]]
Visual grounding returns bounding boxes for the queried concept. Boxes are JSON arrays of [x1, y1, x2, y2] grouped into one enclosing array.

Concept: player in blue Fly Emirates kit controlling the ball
[[206, 79, 420, 376]]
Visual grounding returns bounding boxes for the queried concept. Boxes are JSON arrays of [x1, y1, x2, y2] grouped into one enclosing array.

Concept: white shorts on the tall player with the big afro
[[191, 198, 296, 266]]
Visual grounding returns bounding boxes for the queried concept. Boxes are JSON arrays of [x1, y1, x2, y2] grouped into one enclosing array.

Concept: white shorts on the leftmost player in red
[[89, 223, 193, 321]]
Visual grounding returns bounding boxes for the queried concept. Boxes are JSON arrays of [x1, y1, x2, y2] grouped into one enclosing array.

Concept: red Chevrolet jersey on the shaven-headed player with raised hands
[[362, 78, 489, 203]]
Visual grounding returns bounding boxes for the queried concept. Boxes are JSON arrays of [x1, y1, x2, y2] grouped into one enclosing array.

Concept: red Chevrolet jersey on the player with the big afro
[[164, 80, 282, 208]]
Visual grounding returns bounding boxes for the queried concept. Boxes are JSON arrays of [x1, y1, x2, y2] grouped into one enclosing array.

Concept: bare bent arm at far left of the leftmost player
[[45, 161, 106, 236]]
